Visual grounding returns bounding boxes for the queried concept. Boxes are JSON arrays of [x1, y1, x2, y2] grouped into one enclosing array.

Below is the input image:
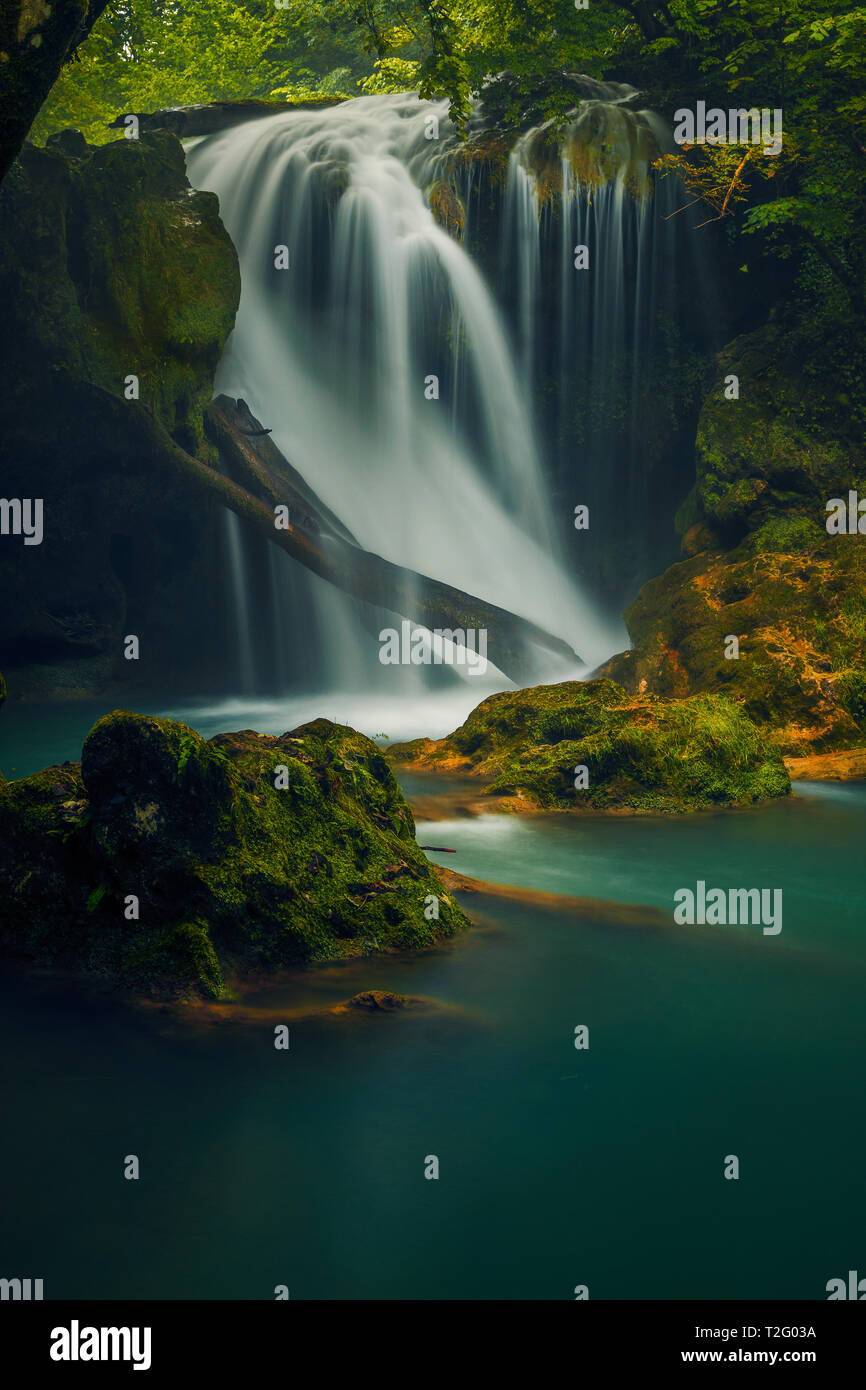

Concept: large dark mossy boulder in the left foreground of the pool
[[0, 710, 466, 998]]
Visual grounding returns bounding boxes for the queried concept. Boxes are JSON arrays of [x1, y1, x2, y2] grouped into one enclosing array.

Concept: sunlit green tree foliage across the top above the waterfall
[[13, 0, 866, 309]]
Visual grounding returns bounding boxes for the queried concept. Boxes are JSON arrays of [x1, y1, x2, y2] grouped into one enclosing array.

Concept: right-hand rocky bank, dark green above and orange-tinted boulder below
[[603, 318, 866, 755]]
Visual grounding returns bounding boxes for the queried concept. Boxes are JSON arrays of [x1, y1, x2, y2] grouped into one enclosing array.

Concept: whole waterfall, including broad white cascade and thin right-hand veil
[[188, 83, 706, 708]]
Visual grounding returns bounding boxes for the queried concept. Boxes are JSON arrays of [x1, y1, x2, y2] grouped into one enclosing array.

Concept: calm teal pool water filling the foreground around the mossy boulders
[[0, 706, 866, 1298]]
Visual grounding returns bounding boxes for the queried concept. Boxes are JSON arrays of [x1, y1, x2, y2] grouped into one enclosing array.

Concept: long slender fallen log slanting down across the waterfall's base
[[96, 386, 578, 684]]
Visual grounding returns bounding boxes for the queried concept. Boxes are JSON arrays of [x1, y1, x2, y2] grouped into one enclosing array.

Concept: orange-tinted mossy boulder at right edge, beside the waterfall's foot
[[602, 518, 866, 755]]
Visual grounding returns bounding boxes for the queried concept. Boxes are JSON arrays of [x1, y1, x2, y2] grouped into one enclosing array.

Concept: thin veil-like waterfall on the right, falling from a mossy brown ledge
[[478, 95, 712, 619]]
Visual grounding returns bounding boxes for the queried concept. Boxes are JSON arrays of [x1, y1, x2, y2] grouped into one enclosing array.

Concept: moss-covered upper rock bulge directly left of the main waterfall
[[0, 132, 240, 449]]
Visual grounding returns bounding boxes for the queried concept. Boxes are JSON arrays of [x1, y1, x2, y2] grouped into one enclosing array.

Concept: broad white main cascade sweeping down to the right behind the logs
[[188, 96, 623, 717]]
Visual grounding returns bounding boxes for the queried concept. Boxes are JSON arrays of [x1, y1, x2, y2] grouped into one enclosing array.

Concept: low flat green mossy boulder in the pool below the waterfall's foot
[[391, 680, 791, 813]]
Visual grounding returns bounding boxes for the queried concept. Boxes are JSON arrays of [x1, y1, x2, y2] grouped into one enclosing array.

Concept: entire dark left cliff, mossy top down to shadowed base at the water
[[0, 132, 240, 696]]
